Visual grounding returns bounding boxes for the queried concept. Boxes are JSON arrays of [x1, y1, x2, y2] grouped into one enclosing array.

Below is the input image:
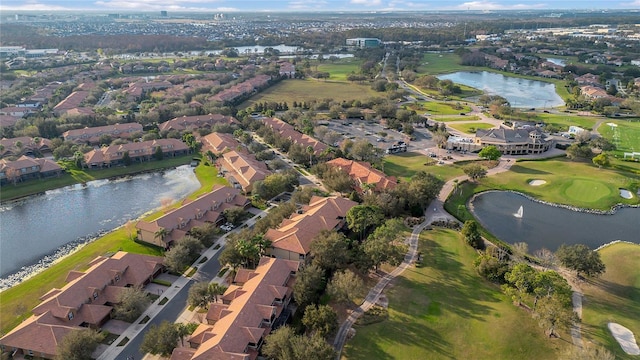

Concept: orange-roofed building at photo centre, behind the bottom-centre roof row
[[264, 196, 358, 260]]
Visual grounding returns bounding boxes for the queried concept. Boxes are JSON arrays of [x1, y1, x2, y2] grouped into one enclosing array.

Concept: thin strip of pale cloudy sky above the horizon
[[0, 0, 640, 12]]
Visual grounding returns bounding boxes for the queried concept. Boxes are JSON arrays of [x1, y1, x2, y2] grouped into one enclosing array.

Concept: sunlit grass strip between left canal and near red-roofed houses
[[0, 164, 227, 333]]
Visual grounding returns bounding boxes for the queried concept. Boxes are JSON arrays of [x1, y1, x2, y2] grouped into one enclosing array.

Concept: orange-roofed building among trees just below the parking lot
[[327, 158, 398, 194]]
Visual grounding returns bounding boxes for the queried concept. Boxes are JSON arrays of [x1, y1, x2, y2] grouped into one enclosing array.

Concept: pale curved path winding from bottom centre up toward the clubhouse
[[333, 160, 514, 360]]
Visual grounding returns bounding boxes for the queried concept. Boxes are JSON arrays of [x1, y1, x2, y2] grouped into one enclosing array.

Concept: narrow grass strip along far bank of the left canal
[[0, 155, 193, 201]]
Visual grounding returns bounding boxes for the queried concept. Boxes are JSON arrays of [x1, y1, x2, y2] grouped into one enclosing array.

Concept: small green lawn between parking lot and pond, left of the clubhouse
[[383, 152, 464, 181]]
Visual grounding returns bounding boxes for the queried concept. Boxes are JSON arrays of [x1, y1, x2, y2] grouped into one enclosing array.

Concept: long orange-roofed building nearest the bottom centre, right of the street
[[171, 257, 300, 360]]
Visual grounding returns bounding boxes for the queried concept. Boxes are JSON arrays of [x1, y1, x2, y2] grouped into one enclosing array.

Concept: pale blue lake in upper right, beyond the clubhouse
[[438, 71, 564, 108]]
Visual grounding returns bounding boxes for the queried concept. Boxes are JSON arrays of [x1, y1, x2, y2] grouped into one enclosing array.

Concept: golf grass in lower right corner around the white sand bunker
[[582, 243, 640, 360]]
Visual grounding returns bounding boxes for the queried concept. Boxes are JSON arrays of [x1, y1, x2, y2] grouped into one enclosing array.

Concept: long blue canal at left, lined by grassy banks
[[0, 165, 200, 289]]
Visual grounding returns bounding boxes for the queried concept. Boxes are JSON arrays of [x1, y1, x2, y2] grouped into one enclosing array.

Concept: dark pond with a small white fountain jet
[[472, 191, 640, 253]]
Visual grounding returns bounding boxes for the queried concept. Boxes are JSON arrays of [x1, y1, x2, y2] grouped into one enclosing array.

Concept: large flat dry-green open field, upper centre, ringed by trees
[[239, 79, 380, 108]]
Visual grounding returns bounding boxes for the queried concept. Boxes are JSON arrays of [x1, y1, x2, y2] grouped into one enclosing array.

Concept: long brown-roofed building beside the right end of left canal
[[136, 185, 250, 248]]
